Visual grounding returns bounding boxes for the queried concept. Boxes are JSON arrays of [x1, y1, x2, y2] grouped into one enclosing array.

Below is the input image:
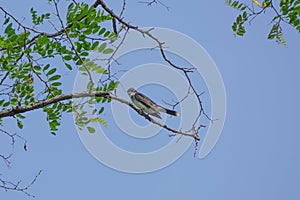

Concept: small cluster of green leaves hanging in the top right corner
[[226, 0, 300, 46]]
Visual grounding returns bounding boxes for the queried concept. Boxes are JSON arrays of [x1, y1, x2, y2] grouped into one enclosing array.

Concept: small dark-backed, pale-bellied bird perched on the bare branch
[[127, 88, 179, 119]]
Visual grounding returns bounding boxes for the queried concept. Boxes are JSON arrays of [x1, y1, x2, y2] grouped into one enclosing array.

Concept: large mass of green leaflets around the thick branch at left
[[0, 1, 117, 135]]
